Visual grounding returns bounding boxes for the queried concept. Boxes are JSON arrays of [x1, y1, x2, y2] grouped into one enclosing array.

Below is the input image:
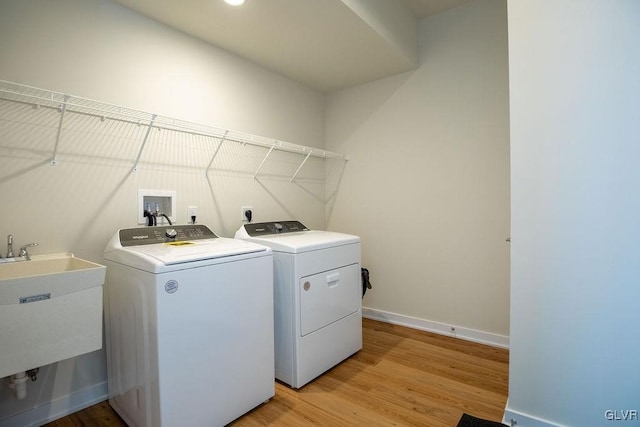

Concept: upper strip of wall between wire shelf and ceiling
[[0, 0, 324, 147]]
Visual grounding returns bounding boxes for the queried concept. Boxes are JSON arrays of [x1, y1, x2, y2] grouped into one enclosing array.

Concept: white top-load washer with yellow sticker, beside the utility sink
[[104, 224, 275, 427]]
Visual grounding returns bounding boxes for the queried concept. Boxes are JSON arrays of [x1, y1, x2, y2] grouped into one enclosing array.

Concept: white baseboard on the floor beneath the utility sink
[[0, 381, 108, 427]]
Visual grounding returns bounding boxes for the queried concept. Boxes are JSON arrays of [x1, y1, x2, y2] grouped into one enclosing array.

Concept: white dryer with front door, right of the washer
[[235, 221, 362, 388]]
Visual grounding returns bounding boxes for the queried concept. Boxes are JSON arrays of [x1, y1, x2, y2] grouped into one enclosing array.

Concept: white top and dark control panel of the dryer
[[235, 221, 360, 254]]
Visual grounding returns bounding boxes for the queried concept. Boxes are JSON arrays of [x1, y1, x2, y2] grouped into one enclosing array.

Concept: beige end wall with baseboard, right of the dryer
[[326, 0, 509, 345]]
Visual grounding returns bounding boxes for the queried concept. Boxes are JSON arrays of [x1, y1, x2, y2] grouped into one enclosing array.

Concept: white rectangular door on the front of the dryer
[[299, 264, 362, 336]]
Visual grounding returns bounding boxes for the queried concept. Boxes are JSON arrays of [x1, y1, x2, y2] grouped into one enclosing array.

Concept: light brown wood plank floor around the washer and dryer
[[47, 319, 509, 427]]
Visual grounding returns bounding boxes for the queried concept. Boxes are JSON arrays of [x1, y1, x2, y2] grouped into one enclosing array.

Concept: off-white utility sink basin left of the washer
[[0, 253, 106, 378]]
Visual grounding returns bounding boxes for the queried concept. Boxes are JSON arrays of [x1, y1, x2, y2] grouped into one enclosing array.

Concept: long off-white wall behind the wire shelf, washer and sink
[[0, 0, 325, 425]]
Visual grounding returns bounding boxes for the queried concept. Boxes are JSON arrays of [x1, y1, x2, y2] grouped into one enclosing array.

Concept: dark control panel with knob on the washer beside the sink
[[119, 224, 218, 246]]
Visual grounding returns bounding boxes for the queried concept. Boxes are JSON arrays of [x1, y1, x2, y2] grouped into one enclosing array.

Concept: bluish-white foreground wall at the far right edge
[[505, 0, 640, 426]]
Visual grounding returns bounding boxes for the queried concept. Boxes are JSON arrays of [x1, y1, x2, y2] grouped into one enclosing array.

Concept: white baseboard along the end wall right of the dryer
[[362, 307, 509, 348]]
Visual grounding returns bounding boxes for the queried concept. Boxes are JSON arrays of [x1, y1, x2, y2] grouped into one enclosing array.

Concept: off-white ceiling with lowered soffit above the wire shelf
[[112, 0, 472, 93]]
